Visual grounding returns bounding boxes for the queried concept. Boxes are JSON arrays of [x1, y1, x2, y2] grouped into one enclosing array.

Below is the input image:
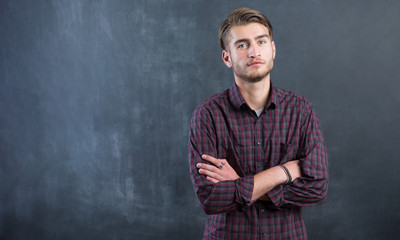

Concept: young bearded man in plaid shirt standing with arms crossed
[[189, 8, 328, 239]]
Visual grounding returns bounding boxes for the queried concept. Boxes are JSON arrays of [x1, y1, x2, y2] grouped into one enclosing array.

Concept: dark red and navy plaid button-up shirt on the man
[[189, 84, 328, 240]]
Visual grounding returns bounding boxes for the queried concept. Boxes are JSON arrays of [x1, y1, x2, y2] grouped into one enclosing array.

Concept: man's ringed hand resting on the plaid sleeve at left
[[196, 154, 239, 183]]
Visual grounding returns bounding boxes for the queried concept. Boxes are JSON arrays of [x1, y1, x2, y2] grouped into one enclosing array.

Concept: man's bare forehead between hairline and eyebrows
[[228, 23, 270, 45]]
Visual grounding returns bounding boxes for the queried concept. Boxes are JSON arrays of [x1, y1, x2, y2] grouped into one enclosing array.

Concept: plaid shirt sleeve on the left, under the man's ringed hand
[[189, 108, 254, 214]]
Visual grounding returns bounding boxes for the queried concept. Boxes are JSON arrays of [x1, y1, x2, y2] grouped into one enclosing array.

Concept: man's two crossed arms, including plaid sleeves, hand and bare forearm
[[189, 104, 328, 214]]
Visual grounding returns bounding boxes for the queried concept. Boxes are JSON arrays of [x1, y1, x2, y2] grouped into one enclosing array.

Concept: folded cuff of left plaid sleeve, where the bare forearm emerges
[[235, 176, 254, 207]]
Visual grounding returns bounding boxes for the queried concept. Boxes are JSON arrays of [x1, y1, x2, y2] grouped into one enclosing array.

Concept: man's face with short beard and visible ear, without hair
[[222, 23, 275, 82]]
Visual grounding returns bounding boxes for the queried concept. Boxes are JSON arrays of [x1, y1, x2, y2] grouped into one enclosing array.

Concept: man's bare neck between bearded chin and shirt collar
[[235, 75, 271, 110]]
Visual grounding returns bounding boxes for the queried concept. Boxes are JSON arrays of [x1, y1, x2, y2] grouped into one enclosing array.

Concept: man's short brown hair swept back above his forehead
[[218, 8, 273, 50]]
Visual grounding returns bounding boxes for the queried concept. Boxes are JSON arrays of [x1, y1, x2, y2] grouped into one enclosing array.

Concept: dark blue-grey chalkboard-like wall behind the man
[[0, 0, 400, 240]]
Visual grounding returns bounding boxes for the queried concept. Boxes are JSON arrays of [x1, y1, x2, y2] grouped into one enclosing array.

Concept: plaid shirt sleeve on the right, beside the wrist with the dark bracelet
[[268, 106, 328, 208]]
